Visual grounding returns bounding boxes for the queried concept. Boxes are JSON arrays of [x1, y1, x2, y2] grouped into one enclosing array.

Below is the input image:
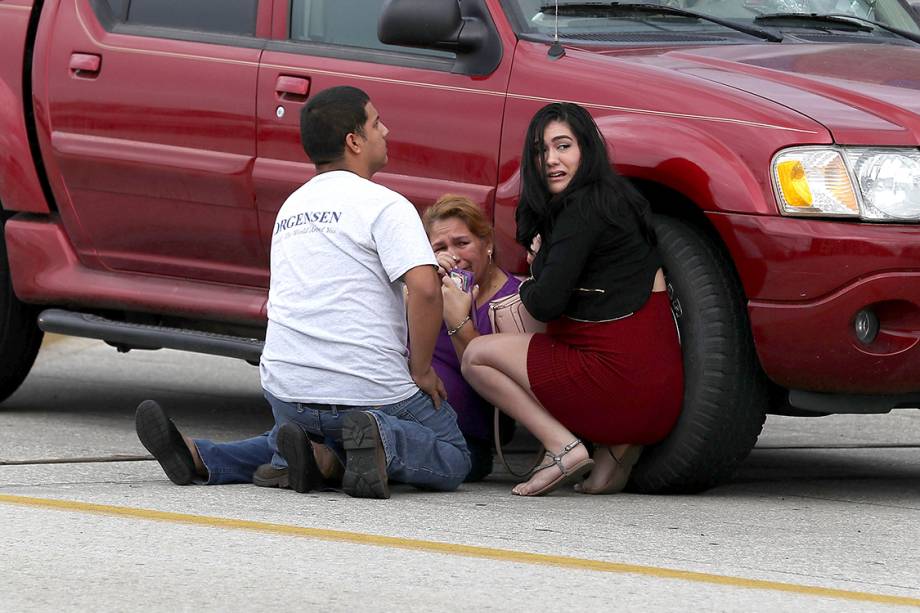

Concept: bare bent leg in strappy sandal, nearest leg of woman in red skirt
[[462, 334, 588, 494]]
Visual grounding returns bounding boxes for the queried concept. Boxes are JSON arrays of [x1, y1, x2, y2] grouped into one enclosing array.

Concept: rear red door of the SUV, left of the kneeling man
[[34, 0, 271, 285]]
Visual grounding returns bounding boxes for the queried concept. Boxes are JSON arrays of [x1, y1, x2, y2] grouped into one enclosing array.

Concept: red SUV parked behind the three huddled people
[[0, 0, 920, 492]]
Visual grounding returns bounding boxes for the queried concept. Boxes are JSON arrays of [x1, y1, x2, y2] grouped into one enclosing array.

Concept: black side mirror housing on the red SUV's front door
[[377, 0, 464, 48]]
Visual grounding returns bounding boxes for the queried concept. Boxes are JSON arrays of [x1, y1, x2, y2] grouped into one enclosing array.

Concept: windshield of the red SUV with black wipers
[[502, 0, 920, 44]]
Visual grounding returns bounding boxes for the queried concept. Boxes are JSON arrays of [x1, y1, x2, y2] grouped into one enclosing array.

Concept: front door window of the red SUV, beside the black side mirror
[[290, 0, 455, 58]]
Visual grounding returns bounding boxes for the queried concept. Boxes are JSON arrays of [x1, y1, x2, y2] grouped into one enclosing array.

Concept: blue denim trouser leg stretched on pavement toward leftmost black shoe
[[194, 427, 270, 485]]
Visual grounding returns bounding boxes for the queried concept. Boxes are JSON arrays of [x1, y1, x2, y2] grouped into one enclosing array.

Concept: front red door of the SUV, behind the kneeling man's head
[[253, 0, 514, 252]]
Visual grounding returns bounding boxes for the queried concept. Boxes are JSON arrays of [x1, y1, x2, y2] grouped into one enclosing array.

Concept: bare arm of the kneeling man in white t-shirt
[[403, 266, 447, 408]]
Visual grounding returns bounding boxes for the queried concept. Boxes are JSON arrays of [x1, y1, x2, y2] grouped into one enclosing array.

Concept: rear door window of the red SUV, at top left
[[100, 0, 259, 36]]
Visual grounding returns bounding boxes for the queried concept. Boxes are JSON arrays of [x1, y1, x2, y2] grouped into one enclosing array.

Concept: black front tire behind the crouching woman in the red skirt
[[629, 216, 768, 494]]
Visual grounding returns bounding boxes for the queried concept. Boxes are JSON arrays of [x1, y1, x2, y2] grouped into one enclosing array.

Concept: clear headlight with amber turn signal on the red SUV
[[772, 147, 920, 221]]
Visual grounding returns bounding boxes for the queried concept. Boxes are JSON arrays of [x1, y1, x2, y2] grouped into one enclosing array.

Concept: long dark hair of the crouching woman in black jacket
[[515, 102, 657, 248]]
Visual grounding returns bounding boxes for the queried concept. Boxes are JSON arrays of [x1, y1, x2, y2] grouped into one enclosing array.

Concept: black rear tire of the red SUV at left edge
[[0, 218, 44, 402]]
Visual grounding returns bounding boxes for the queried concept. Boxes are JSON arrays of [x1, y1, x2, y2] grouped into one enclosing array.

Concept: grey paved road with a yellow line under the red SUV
[[0, 337, 920, 613]]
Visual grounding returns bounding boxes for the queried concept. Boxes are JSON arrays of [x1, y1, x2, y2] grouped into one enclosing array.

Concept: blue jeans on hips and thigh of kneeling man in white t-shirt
[[265, 391, 470, 491]]
